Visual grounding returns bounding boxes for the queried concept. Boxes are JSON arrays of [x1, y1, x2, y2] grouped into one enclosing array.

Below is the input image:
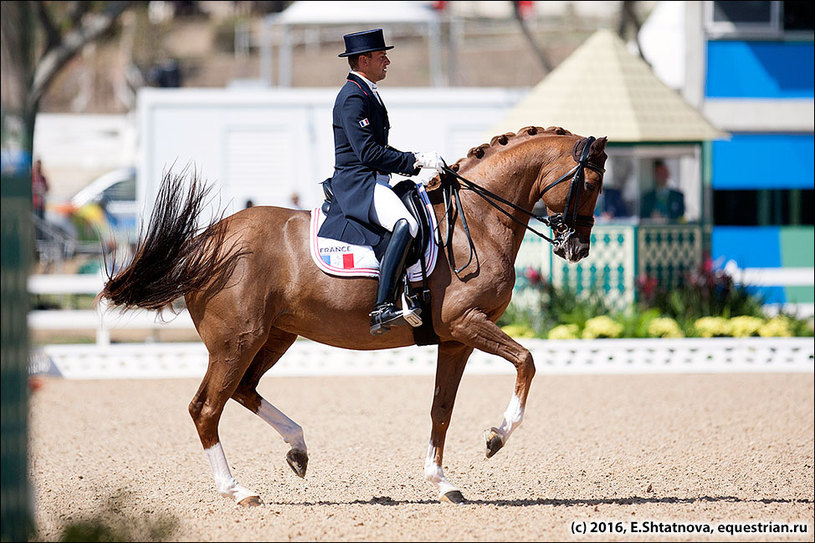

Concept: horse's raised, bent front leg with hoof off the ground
[[452, 311, 535, 458]]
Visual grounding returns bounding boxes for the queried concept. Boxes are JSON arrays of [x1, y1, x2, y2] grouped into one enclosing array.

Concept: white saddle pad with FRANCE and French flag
[[309, 183, 438, 281]]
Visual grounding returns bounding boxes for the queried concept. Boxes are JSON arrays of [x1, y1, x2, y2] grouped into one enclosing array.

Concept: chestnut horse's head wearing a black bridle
[[538, 131, 608, 263]]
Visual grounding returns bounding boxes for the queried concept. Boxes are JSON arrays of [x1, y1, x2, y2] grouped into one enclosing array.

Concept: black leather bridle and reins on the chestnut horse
[[436, 136, 606, 276]]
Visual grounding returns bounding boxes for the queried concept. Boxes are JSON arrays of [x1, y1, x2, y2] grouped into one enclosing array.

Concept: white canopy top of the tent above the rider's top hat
[[272, 0, 437, 25]]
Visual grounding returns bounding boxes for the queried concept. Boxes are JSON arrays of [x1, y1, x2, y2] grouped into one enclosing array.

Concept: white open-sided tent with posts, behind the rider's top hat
[[261, 1, 442, 87]]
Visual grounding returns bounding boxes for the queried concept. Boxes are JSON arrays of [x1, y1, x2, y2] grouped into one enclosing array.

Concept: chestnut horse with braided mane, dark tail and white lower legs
[[99, 126, 607, 506]]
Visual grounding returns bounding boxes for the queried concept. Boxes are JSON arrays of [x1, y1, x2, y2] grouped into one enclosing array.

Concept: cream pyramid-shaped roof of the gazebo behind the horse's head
[[491, 30, 728, 143]]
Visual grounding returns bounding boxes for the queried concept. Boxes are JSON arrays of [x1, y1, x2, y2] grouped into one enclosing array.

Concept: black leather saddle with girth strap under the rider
[[321, 178, 439, 345]]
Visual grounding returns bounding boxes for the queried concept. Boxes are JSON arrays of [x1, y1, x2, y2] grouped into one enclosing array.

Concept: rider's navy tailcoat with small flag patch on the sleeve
[[319, 73, 419, 246]]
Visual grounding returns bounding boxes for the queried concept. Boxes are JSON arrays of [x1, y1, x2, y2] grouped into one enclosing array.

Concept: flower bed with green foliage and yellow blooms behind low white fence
[[498, 259, 813, 339]]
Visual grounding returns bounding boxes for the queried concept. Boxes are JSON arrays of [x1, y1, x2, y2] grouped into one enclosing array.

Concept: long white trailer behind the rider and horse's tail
[[137, 88, 524, 226]]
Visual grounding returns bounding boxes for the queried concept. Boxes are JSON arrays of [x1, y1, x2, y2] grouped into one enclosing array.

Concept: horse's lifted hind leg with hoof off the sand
[[232, 329, 308, 477]]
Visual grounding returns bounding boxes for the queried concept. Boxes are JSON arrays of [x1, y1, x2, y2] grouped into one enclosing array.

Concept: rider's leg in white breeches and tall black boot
[[371, 178, 421, 335]]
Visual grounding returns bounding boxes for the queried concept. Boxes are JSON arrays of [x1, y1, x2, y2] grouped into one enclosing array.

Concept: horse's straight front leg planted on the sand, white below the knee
[[424, 342, 473, 503]]
